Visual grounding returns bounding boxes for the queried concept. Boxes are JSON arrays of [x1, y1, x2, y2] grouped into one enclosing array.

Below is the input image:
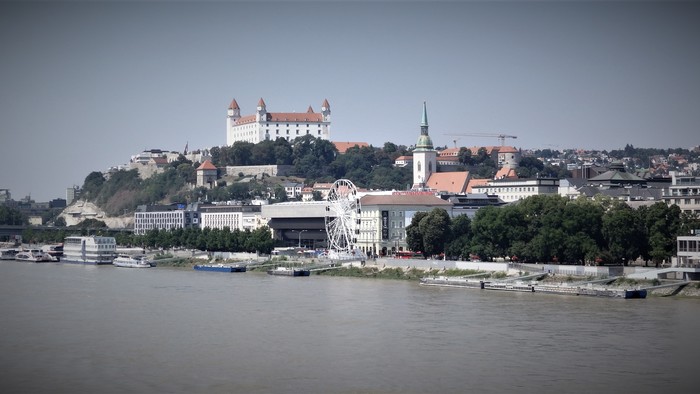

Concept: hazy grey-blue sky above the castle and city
[[0, 1, 700, 201]]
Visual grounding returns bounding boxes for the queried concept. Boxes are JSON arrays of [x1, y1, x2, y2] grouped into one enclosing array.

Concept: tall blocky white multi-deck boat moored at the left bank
[[61, 235, 117, 264]]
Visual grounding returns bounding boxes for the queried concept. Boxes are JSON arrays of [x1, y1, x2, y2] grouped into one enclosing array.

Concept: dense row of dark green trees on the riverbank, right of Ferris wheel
[[406, 195, 700, 266]]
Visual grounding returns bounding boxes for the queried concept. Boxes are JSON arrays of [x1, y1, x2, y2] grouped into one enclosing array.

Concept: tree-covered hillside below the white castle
[[81, 136, 412, 216]]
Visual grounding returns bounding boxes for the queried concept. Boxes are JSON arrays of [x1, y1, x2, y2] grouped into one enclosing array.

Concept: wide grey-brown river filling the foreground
[[0, 261, 700, 393]]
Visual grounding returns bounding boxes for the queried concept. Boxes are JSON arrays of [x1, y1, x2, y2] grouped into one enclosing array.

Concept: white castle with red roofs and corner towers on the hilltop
[[226, 98, 331, 146]]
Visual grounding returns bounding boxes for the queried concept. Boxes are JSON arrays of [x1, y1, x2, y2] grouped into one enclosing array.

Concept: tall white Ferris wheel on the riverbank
[[326, 179, 360, 257]]
